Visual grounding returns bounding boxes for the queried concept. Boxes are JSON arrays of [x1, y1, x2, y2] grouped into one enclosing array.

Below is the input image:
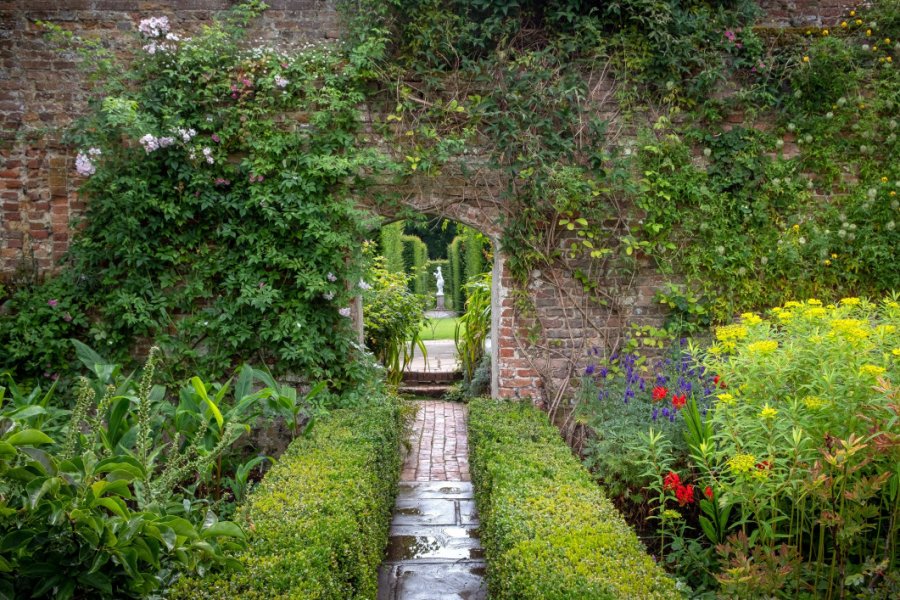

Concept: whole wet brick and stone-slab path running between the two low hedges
[[378, 400, 487, 600]]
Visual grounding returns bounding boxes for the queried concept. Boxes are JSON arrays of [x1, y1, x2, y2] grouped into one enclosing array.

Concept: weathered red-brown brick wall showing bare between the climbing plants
[[0, 0, 848, 407]]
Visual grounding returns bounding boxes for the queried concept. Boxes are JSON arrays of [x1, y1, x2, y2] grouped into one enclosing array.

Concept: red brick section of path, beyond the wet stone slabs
[[400, 400, 470, 481]]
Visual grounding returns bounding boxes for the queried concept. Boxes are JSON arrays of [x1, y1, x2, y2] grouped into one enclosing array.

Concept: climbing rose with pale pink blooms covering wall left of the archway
[[0, 3, 394, 389]]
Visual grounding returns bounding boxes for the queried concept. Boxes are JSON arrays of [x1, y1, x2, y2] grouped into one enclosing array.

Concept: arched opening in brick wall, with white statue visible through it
[[362, 213, 498, 399]]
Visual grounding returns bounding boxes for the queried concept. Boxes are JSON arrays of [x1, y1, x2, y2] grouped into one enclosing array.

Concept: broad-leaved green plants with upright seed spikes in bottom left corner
[[0, 349, 253, 598]]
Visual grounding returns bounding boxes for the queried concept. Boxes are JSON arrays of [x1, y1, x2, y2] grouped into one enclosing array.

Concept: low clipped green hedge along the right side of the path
[[469, 400, 680, 600]]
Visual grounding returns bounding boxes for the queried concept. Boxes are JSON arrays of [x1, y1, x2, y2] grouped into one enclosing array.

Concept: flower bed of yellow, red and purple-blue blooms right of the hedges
[[587, 298, 900, 598]]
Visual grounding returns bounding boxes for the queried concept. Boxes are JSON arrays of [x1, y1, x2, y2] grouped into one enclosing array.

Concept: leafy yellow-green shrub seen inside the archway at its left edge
[[363, 256, 426, 385]]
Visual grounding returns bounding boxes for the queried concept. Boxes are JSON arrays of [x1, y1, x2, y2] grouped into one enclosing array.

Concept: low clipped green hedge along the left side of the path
[[170, 399, 401, 600]]
